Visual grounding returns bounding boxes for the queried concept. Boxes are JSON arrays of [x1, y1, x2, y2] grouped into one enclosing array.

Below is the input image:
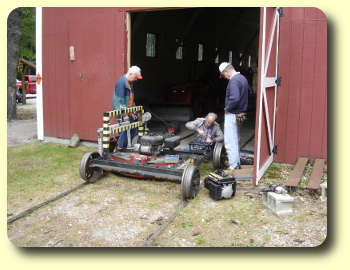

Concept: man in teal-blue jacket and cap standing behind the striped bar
[[113, 66, 142, 148]]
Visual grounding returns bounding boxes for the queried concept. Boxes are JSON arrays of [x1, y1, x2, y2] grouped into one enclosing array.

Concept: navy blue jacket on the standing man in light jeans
[[225, 72, 252, 114]]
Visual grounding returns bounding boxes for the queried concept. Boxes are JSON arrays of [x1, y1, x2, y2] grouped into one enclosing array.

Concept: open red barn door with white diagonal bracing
[[253, 7, 282, 184]]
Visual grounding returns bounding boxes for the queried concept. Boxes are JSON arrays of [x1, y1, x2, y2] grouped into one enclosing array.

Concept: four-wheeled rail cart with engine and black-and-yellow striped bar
[[79, 106, 225, 200]]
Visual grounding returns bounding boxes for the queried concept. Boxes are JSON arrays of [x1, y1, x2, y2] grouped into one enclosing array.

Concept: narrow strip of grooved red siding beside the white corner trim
[[42, 9, 71, 137]]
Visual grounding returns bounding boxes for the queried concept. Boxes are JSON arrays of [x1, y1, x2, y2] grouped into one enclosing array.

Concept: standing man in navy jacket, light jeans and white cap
[[219, 62, 252, 170]]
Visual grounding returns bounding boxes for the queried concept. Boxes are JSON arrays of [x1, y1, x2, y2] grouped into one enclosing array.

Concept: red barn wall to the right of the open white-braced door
[[275, 8, 327, 163]]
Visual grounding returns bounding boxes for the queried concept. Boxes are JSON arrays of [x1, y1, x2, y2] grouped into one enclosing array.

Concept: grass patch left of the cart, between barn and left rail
[[7, 143, 94, 200]]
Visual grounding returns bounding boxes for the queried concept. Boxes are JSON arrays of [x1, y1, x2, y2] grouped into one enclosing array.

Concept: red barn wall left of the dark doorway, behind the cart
[[42, 8, 131, 140]]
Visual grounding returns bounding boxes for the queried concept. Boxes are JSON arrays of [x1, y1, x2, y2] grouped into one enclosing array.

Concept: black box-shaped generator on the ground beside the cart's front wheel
[[204, 169, 236, 201]]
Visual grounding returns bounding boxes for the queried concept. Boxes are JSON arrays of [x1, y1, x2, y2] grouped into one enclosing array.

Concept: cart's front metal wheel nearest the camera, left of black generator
[[181, 164, 200, 200]]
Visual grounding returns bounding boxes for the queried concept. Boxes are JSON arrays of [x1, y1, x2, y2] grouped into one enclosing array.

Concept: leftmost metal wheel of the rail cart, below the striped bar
[[79, 151, 102, 183]]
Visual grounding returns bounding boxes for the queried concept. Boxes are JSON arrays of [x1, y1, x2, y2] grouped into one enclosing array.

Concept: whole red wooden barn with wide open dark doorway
[[37, 7, 327, 184]]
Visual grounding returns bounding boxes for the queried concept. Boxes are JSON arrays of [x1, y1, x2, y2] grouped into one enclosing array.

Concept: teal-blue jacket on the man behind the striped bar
[[113, 74, 135, 119]]
